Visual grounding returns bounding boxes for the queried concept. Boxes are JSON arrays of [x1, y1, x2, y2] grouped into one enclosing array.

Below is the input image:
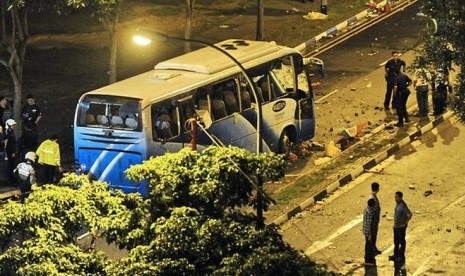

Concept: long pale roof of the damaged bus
[[86, 39, 299, 107]]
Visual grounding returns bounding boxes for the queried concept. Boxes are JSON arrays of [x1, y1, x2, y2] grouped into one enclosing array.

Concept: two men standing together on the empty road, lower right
[[362, 182, 412, 266]]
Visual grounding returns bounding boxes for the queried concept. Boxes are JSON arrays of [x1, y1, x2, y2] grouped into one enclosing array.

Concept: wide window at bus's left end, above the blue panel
[[76, 95, 141, 131]]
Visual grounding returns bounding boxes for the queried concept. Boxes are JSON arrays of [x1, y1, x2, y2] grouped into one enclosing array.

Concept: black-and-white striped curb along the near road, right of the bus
[[270, 111, 454, 225]]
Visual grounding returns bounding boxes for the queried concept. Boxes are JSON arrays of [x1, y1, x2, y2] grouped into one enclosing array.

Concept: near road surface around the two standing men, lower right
[[282, 117, 465, 275]]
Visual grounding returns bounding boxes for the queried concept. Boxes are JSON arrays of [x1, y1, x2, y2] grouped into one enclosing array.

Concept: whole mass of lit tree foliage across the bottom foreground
[[0, 147, 336, 275]]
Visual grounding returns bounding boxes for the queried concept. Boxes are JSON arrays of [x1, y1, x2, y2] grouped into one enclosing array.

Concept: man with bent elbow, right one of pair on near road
[[389, 191, 412, 262]]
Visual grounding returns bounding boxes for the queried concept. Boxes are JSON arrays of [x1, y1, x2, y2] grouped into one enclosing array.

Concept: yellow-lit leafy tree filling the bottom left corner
[[0, 177, 130, 275]]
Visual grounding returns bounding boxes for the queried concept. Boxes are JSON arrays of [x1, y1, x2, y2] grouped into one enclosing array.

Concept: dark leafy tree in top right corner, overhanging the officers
[[413, 0, 465, 123]]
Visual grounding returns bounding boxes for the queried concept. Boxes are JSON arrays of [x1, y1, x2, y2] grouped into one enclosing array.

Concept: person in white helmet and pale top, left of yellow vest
[[14, 151, 36, 203]]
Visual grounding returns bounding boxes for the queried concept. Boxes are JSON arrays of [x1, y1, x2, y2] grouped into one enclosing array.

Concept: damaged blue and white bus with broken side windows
[[74, 39, 315, 195]]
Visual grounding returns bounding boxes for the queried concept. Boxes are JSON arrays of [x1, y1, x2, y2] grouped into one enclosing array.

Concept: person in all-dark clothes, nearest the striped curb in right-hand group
[[394, 73, 412, 127]]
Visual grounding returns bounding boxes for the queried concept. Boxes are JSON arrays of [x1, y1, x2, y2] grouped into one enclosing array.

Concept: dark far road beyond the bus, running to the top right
[[317, 1, 427, 99]]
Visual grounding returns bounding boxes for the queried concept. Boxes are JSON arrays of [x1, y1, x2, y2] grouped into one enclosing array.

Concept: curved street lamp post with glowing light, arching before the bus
[[133, 30, 265, 228]]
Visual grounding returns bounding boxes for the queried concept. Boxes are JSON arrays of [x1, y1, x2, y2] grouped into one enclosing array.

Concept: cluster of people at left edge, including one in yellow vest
[[0, 95, 62, 201]]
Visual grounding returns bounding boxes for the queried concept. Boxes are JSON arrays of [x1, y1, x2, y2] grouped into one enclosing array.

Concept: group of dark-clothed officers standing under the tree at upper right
[[384, 51, 452, 127]]
